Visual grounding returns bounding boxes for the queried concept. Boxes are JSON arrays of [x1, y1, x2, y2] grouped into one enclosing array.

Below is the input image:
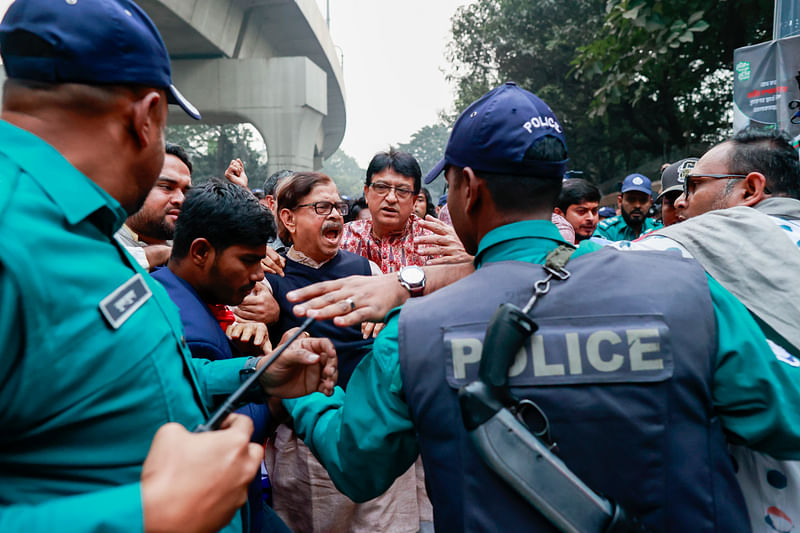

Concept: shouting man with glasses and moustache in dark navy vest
[[266, 172, 430, 533]]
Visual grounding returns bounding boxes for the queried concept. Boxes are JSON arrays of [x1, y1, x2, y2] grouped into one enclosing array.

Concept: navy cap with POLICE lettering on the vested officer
[[425, 82, 567, 183]]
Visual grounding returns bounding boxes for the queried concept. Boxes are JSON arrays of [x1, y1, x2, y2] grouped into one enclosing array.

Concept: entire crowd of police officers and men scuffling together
[[0, 0, 800, 533]]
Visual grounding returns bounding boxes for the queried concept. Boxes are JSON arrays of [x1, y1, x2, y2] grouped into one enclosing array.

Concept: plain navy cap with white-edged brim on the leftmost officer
[[0, 0, 200, 119]]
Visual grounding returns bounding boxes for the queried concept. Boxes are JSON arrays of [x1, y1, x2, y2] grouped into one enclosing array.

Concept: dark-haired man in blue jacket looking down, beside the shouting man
[[152, 179, 288, 531]]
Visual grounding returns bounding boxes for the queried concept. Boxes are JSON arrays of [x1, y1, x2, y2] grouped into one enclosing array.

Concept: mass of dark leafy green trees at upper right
[[448, 0, 771, 191]]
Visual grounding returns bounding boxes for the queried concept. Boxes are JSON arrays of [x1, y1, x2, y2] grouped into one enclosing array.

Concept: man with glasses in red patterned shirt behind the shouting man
[[340, 148, 436, 274]]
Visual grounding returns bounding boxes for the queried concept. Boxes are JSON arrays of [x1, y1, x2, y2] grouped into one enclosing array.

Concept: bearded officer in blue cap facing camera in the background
[[594, 174, 661, 241]]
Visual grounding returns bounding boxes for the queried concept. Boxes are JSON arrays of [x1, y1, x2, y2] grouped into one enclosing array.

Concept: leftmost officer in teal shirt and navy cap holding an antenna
[[0, 0, 334, 532]]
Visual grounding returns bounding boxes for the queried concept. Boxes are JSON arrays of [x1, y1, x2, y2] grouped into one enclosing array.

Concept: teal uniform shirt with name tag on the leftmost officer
[[0, 121, 245, 533]]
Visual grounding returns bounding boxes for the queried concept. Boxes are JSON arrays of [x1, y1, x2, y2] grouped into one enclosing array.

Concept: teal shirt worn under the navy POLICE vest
[[284, 221, 800, 501]]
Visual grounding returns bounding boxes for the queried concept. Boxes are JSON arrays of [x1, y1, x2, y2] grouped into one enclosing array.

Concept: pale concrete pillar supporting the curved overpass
[[170, 57, 328, 173]]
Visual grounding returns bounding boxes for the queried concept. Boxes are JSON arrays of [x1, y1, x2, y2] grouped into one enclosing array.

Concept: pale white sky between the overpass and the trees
[[317, 0, 470, 168]]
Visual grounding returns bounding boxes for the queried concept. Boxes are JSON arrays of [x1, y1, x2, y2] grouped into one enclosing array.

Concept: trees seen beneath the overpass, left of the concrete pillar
[[166, 124, 267, 188]]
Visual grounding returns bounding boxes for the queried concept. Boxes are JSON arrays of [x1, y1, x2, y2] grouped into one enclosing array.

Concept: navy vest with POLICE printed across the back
[[399, 249, 748, 533]]
